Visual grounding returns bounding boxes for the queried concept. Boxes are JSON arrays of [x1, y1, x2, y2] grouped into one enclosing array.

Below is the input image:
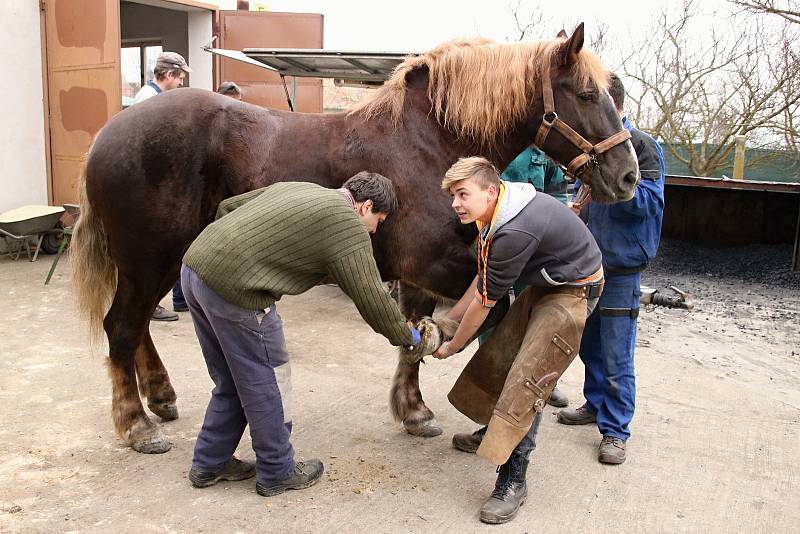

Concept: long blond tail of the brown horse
[[70, 161, 117, 340]]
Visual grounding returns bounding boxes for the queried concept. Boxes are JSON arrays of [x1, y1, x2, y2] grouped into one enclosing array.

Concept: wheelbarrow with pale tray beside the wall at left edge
[[0, 206, 64, 261]]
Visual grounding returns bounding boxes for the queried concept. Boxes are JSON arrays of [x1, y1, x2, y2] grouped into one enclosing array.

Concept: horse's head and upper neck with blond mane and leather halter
[[351, 31, 639, 202]]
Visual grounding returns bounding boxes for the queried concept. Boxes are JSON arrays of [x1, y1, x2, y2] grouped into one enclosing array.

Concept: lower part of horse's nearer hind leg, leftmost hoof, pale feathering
[[103, 272, 172, 453]]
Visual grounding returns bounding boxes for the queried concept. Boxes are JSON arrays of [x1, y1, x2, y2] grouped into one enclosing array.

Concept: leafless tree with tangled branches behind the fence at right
[[622, 0, 800, 176]]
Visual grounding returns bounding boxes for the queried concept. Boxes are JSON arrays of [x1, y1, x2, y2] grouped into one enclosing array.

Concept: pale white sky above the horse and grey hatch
[[212, 0, 730, 52]]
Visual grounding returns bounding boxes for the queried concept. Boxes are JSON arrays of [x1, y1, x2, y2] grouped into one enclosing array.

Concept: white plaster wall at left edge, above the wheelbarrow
[[0, 0, 47, 212]]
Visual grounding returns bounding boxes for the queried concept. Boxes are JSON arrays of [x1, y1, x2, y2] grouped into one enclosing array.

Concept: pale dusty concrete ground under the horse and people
[[0, 252, 800, 533]]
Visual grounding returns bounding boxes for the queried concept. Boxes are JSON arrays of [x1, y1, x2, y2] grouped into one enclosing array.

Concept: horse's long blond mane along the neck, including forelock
[[350, 38, 608, 146]]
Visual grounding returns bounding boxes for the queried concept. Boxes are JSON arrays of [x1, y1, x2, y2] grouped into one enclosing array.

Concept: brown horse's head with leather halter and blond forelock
[[534, 23, 639, 202]]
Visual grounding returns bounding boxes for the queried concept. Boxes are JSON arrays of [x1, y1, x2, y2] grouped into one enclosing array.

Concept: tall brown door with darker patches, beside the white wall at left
[[42, 0, 122, 204]]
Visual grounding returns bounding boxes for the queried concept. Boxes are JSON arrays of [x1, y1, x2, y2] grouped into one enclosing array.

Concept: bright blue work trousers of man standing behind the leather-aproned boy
[[580, 273, 641, 440]]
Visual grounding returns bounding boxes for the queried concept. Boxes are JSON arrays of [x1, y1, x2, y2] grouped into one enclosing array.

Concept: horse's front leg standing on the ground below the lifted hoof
[[389, 283, 442, 438]]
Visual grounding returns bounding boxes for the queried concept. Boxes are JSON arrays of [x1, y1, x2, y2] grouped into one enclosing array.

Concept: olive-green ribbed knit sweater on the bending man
[[183, 182, 412, 345]]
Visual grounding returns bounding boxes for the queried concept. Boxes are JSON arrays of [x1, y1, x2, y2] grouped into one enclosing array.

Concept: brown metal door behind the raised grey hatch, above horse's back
[[217, 11, 323, 113]]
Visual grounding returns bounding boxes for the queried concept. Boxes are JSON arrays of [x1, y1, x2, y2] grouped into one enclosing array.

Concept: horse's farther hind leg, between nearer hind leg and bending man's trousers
[[135, 272, 178, 421]]
